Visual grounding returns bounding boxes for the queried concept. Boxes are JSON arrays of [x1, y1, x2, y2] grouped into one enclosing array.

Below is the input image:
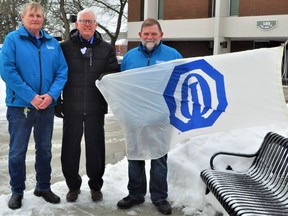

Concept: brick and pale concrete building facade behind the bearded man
[[128, 0, 288, 57]]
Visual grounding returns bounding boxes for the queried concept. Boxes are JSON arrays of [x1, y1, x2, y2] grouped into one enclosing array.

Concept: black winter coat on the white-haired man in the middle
[[61, 29, 118, 115]]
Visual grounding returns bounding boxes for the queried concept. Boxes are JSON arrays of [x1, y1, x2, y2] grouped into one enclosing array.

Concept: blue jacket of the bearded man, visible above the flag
[[121, 42, 182, 71]]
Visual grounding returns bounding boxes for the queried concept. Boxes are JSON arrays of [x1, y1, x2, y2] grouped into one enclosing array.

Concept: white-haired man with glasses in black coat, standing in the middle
[[61, 8, 118, 202]]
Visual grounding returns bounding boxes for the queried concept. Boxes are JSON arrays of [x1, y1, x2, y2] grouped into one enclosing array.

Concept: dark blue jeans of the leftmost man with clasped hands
[[7, 107, 54, 194]]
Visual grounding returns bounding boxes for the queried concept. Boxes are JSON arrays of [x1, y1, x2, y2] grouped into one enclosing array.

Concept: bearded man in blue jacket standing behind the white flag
[[117, 18, 182, 215]]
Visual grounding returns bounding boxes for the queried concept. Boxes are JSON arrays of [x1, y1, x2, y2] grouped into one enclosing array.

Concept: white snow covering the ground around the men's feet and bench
[[0, 75, 288, 216]]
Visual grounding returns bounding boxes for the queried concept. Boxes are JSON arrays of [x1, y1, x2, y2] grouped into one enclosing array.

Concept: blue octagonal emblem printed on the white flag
[[164, 59, 228, 132]]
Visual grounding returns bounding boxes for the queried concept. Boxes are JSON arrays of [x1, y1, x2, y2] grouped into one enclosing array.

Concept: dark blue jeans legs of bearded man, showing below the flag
[[128, 154, 168, 203]]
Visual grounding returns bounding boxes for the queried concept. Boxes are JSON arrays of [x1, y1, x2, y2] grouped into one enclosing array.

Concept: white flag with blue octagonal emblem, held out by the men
[[96, 46, 288, 160]]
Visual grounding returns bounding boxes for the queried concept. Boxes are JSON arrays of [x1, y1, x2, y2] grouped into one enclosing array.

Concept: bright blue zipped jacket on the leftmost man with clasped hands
[[0, 26, 68, 108]]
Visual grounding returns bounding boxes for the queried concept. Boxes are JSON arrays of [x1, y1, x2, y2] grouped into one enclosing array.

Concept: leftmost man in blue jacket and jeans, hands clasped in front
[[0, 2, 68, 209]]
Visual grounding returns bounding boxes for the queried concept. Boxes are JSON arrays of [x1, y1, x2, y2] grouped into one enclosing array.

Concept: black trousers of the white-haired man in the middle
[[61, 113, 105, 190]]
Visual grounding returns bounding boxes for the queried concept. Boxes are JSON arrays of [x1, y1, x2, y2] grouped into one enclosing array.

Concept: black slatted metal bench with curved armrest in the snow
[[200, 132, 288, 216]]
